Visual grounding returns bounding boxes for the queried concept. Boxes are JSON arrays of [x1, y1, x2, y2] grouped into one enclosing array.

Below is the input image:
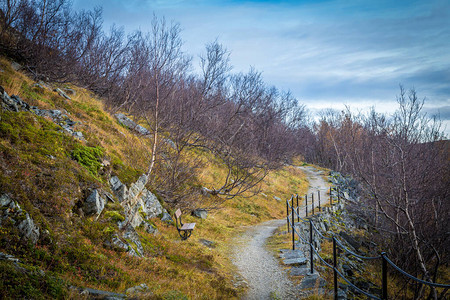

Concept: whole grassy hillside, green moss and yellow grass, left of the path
[[0, 59, 307, 299]]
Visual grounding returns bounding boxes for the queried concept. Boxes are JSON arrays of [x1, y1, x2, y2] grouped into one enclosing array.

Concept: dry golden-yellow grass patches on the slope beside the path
[[0, 58, 314, 299]]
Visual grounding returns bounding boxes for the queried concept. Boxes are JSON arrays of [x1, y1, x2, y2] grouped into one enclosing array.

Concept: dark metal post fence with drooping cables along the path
[[286, 187, 450, 300]]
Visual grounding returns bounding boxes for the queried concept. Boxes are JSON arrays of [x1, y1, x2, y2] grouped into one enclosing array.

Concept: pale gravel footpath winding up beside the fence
[[232, 166, 328, 300]]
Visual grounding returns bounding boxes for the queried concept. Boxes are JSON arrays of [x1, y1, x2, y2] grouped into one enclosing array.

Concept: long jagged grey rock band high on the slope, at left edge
[[0, 86, 84, 140]]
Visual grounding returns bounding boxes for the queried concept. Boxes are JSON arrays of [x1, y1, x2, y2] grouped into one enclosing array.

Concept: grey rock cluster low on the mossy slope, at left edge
[[0, 195, 39, 244]]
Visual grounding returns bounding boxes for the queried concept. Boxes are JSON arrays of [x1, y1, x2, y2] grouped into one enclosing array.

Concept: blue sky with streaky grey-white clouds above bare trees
[[73, 0, 450, 135]]
